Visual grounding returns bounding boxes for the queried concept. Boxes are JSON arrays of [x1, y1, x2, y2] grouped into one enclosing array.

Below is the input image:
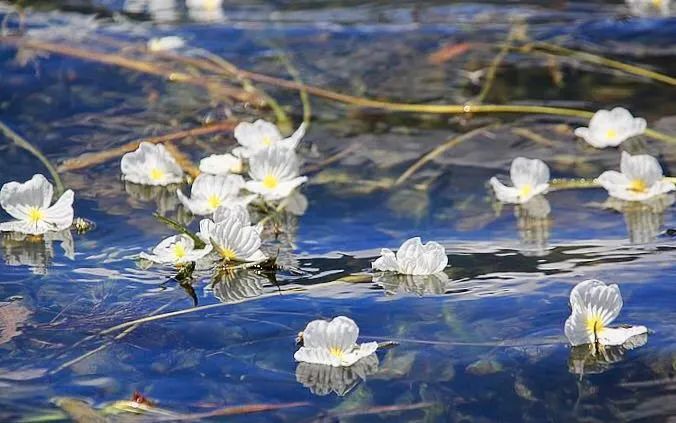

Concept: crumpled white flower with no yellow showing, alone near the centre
[[371, 237, 448, 275]]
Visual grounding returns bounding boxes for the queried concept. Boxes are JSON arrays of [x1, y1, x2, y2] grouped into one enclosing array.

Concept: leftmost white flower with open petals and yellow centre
[[0, 174, 74, 235]]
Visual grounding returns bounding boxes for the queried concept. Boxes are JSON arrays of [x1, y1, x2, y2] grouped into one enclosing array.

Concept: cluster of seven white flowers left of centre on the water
[[121, 120, 307, 266]]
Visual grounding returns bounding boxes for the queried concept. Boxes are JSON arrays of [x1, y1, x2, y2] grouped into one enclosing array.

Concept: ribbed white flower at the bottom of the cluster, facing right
[[197, 206, 266, 262]]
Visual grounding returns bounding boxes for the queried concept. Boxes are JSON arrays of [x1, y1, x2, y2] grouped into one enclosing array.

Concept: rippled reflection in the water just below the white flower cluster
[[210, 270, 267, 303]]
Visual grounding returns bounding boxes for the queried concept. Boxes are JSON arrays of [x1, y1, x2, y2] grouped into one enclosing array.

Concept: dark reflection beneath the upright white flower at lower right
[[568, 333, 648, 375]]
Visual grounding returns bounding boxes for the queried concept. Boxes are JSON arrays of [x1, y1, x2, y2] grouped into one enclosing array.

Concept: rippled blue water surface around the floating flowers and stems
[[0, 0, 676, 421]]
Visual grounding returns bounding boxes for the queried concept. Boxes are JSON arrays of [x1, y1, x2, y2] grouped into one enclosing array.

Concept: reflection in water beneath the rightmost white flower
[[603, 193, 676, 244]]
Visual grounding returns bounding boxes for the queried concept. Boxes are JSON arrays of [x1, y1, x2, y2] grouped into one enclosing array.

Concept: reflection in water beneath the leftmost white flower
[[2, 230, 75, 275]]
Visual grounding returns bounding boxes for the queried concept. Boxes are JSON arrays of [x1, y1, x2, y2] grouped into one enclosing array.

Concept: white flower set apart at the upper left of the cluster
[[120, 142, 183, 186]]
